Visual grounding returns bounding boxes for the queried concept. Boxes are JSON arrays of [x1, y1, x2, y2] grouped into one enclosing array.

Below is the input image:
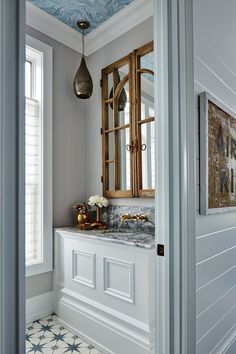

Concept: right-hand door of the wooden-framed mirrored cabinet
[[136, 45, 155, 197]]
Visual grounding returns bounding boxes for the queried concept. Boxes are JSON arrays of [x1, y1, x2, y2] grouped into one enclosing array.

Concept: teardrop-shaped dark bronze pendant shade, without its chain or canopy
[[74, 56, 93, 99]]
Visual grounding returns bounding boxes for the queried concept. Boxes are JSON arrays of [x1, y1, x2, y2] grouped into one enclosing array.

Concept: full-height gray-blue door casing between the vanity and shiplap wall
[[154, 0, 196, 354]]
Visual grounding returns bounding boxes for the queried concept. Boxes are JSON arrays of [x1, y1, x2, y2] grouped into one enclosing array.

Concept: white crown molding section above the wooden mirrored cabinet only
[[86, 0, 153, 55]]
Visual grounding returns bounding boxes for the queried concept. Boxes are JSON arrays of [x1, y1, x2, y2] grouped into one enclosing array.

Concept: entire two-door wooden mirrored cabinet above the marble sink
[[101, 42, 155, 198]]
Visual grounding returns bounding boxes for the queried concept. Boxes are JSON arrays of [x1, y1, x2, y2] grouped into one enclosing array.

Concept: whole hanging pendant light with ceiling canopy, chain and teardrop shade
[[74, 20, 93, 99]]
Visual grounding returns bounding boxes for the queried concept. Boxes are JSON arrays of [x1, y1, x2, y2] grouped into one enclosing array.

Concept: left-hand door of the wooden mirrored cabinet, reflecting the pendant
[[102, 56, 132, 198]]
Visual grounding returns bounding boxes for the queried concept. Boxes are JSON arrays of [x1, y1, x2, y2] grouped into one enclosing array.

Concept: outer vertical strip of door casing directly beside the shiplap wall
[[179, 0, 195, 354]]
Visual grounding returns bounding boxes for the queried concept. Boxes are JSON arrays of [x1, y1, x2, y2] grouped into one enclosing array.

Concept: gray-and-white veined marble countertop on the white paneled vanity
[[55, 227, 155, 249]]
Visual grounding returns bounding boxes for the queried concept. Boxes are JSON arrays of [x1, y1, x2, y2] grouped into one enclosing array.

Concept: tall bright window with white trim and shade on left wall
[[25, 36, 52, 276]]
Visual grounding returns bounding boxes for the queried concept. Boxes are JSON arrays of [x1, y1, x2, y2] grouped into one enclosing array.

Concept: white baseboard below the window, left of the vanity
[[26, 291, 54, 324]]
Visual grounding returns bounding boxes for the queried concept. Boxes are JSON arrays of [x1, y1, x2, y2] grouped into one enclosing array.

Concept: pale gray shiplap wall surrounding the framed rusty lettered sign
[[194, 0, 236, 354]]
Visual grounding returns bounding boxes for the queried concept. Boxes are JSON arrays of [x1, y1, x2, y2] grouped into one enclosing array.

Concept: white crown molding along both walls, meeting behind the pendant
[[26, 0, 153, 56]]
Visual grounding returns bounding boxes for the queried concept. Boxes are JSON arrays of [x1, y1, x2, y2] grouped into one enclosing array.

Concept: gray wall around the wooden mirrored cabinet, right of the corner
[[86, 20, 154, 206]]
